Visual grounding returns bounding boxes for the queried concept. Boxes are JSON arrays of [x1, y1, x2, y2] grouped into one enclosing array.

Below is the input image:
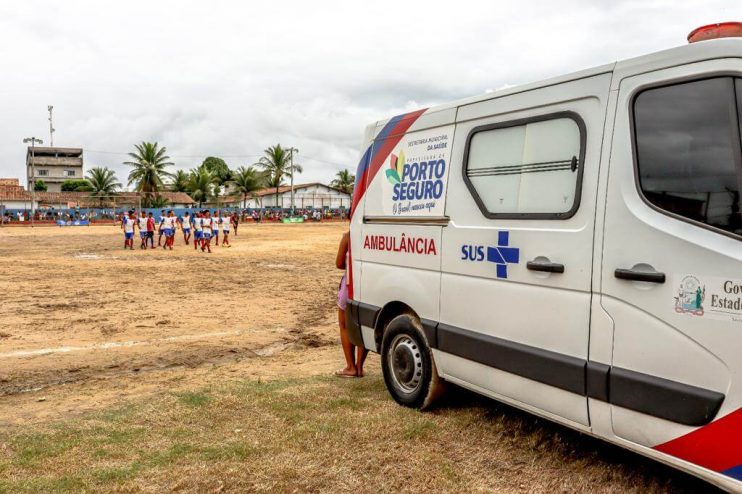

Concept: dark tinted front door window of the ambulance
[[633, 77, 742, 239]]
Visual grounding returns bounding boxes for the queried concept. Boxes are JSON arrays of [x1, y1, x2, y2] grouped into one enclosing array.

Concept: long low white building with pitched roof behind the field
[[218, 183, 351, 209]]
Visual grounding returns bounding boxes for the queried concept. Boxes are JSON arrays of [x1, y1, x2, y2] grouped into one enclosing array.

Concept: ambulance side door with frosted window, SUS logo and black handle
[[435, 73, 611, 426]]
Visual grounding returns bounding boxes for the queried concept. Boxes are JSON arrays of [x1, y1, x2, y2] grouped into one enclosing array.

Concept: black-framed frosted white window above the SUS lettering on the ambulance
[[464, 112, 585, 219]]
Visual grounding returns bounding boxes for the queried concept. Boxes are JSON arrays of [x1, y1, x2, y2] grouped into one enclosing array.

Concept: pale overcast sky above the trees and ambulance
[[0, 0, 742, 189]]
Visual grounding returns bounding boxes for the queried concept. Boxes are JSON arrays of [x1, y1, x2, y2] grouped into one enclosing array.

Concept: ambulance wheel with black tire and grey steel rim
[[381, 314, 443, 410]]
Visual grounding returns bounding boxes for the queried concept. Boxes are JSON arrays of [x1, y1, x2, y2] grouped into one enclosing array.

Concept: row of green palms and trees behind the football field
[[34, 142, 355, 208]]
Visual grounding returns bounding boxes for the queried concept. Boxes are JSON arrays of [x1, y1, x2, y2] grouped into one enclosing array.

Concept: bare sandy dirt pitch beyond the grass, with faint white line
[[0, 223, 346, 425]]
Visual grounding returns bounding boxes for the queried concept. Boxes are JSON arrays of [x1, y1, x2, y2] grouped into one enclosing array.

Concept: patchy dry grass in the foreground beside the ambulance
[[0, 376, 720, 493]]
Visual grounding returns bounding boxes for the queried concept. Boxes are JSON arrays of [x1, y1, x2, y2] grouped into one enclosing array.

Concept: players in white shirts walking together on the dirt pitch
[[120, 209, 239, 253]]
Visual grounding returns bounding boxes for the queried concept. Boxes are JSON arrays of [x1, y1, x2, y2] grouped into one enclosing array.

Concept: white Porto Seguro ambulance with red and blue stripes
[[346, 23, 742, 491]]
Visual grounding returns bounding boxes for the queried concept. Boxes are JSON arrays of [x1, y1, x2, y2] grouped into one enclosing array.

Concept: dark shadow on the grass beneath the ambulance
[[434, 383, 723, 494]]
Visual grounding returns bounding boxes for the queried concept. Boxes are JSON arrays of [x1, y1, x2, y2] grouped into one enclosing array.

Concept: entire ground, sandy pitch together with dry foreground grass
[[0, 224, 710, 492]]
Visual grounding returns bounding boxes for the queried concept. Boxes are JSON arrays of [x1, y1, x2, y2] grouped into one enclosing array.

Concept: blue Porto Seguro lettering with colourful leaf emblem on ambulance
[[386, 151, 446, 201]]
